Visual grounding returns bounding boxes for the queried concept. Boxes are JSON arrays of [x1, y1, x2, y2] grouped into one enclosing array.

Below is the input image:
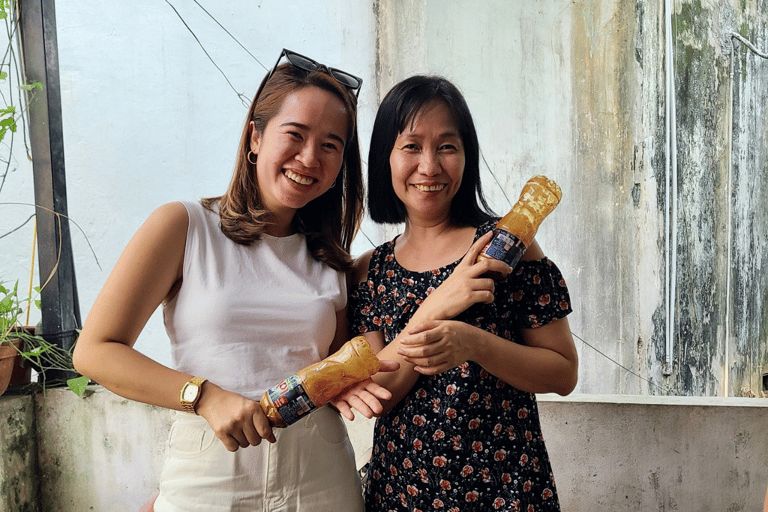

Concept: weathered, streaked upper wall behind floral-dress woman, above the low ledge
[[377, 0, 768, 396]]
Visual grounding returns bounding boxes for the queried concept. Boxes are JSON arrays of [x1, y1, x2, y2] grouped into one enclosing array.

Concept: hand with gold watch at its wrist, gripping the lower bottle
[[196, 381, 276, 452]]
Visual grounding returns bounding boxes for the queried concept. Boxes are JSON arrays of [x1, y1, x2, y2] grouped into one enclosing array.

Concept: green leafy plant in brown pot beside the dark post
[[0, 282, 88, 395]]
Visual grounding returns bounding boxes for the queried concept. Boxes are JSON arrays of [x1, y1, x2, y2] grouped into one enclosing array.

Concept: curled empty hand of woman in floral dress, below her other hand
[[397, 320, 474, 375]]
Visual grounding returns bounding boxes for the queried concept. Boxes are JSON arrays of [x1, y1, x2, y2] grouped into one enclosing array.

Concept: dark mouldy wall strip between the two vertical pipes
[[674, 2, 728, 395]]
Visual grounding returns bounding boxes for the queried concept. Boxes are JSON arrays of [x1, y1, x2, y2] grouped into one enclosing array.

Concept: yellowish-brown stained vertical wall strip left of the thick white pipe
[[571, 1, 657, 394]]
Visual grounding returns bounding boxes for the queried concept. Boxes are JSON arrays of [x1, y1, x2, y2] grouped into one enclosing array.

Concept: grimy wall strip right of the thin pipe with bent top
[[729, 2, 768, 393]]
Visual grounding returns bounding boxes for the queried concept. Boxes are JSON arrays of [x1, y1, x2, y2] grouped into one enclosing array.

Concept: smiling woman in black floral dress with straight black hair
[[349, 76, 578, 512]]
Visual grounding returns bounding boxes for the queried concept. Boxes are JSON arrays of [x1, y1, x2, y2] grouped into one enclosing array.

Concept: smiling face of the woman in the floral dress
[[389, 101, 465, 223]]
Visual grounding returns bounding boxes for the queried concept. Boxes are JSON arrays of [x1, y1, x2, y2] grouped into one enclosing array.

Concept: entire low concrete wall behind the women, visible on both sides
[[0, 387, 768, 512]]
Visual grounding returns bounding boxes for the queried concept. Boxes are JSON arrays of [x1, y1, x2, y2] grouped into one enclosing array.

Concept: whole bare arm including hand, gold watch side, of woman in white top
[[73, 203, 274, 451]]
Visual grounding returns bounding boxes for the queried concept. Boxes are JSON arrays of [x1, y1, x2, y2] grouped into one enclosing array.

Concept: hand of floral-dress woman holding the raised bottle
[[414, 231, 512, 322]]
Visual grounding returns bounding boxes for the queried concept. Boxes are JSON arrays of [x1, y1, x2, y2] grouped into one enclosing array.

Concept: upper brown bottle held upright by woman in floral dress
[[477, 176, 563, 279]]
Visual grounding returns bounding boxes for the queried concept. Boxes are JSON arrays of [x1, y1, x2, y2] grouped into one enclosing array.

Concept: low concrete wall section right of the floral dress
[[539, 395, 768, 512]]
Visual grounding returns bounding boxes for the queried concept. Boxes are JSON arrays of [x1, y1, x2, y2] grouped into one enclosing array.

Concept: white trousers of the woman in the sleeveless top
[[154, 407, 364, 512]]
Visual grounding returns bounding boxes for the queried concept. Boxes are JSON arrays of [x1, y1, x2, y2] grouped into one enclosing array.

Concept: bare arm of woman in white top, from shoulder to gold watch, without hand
[[73, 203, 191, 410]]
